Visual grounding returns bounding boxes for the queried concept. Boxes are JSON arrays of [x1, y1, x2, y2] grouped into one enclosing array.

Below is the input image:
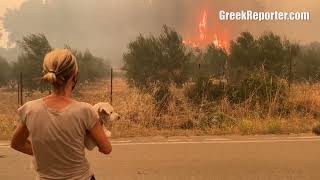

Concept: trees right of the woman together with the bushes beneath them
[[123, 26, 320, 106]]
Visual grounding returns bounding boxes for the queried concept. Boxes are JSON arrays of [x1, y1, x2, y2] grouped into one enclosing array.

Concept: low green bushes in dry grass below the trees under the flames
[[185, 70, 289, 114]]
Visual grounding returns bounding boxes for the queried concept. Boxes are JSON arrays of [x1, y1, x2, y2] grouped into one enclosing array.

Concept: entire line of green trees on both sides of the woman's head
[[0, 26, 320, 93]]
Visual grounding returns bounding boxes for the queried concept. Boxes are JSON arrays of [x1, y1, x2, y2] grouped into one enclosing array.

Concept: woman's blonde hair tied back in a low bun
[[42, 49, 78, 86]]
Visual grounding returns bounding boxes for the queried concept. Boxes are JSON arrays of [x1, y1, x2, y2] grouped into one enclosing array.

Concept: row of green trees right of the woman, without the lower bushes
[[123, 26, 320, 89]]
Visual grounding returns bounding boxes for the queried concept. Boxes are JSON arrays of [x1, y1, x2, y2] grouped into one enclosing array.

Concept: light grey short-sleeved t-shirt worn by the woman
[[18, 98, 98, 180]]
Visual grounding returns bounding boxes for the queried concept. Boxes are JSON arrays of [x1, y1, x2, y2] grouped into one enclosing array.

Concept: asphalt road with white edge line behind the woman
[[0, 135, 320, 180]]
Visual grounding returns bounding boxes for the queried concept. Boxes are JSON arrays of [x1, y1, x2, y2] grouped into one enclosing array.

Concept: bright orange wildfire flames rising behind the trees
[[183, 11, 229, 50]]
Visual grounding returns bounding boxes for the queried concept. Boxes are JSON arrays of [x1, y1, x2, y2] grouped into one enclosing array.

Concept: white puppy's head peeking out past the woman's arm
[[93, 103, 120, 123]]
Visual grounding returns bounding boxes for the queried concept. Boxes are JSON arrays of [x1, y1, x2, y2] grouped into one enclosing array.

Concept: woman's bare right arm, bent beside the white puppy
[[90, 122, 112, 154]]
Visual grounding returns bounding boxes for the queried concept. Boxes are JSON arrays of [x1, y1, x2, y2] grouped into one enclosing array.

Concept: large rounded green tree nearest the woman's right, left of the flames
[[123, 26, 191, 90]]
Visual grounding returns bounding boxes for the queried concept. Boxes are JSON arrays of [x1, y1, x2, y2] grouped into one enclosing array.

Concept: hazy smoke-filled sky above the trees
[[0, 0, 320, 64]]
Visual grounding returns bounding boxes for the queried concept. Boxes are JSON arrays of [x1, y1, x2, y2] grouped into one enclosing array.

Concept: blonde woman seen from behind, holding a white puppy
[[11, 49, 112, 180]]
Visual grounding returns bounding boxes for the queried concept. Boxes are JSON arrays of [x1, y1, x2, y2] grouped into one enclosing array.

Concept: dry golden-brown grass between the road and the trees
[[0, 79, 320, 139]]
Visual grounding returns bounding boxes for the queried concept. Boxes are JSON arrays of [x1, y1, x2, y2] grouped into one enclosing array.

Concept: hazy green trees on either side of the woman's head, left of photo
[[0, 34, 110, 90]]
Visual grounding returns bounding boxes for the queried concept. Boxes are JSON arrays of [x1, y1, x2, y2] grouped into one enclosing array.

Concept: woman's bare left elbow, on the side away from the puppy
[[11, 124, 33, 156]]
